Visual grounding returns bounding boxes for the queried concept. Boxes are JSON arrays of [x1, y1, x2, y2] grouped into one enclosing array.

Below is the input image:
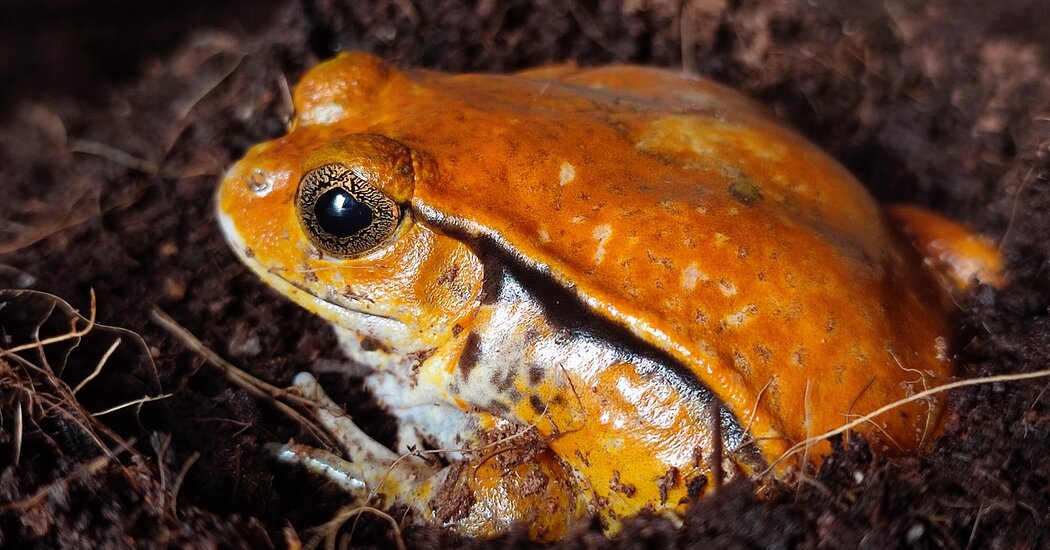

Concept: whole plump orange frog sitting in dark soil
[[216, 52, 1002, 541]]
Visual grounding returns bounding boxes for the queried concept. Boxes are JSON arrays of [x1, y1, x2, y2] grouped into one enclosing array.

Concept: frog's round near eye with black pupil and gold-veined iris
[[295, 164, 401, 256]]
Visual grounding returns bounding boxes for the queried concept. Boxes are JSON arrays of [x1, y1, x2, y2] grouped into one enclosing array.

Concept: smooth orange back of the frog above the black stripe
[[297, 56, 950, 456]]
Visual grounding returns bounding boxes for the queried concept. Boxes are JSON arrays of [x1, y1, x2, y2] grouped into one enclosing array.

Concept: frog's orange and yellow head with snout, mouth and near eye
[[217, 133, 482, 354]]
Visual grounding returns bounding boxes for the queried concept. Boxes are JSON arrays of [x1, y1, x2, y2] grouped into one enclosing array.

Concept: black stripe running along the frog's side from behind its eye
[[417, 203, 767, 470]]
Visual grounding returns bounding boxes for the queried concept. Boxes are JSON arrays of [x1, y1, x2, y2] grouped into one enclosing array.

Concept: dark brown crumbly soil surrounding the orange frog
[[0, 0, 1050, 548]]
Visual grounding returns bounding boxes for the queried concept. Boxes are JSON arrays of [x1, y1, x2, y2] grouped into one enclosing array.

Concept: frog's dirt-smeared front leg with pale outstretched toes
[[275, 373, 586, 541]]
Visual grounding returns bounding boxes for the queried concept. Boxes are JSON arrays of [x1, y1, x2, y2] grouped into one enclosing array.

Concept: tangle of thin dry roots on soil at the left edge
[[0, 290, 207, 545]]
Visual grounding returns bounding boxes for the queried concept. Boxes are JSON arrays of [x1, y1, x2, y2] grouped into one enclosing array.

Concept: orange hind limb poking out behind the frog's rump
[[888, 205, 1005, 292]]
